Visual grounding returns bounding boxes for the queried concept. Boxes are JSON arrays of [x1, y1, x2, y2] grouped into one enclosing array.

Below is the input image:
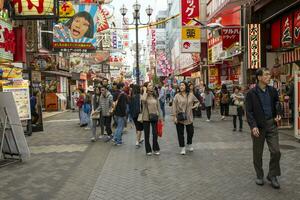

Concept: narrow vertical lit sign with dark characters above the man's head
[[248, 24, 261, 69]]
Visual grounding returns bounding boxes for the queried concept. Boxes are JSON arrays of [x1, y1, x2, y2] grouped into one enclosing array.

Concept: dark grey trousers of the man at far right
[[252, 119, 281, 178]]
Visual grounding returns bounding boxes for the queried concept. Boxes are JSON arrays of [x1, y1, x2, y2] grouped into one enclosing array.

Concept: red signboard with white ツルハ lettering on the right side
[[222, 28, 240, 50]]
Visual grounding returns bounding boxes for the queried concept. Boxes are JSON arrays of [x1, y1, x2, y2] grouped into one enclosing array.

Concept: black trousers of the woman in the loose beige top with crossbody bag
[[176, 123, 194, 147]]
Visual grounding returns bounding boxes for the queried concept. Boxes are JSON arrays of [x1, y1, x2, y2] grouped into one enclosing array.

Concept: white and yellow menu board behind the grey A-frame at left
[[2, 80, 31, 120]]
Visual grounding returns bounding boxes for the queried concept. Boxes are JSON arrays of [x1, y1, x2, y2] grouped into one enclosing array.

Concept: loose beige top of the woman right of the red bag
[[172, 93, 199, 125]]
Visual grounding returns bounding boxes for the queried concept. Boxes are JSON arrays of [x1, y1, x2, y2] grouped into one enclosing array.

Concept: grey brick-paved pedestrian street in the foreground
[[0, 109, 300, 200]]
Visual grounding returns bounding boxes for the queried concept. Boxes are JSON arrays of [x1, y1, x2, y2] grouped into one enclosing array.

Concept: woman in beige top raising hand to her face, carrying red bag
[[141, 82, 160, 156]]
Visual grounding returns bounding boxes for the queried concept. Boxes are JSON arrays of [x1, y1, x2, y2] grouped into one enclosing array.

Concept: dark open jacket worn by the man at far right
[[246, 85, 281, 129]]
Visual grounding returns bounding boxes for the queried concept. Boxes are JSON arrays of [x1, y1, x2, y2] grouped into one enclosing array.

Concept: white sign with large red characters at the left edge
[[0, 19, 16, 62]]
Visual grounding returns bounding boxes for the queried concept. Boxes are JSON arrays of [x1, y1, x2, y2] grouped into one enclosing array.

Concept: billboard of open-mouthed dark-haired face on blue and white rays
[[53, 4, 99, 52]]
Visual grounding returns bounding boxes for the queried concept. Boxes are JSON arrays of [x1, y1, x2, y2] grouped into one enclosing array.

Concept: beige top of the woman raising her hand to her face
[[141, 93, 160, 121]]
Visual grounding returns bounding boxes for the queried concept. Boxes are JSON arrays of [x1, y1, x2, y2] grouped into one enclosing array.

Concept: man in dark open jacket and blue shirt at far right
[[246, 68, 281, 189]]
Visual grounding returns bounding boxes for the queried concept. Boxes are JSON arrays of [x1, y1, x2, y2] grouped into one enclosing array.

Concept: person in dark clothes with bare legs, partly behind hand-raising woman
[[129, 85, 144, 148]]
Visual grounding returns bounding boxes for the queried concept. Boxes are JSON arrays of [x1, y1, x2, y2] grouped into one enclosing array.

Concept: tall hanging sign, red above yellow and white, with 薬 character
[[181, 0, 201, 53]]
